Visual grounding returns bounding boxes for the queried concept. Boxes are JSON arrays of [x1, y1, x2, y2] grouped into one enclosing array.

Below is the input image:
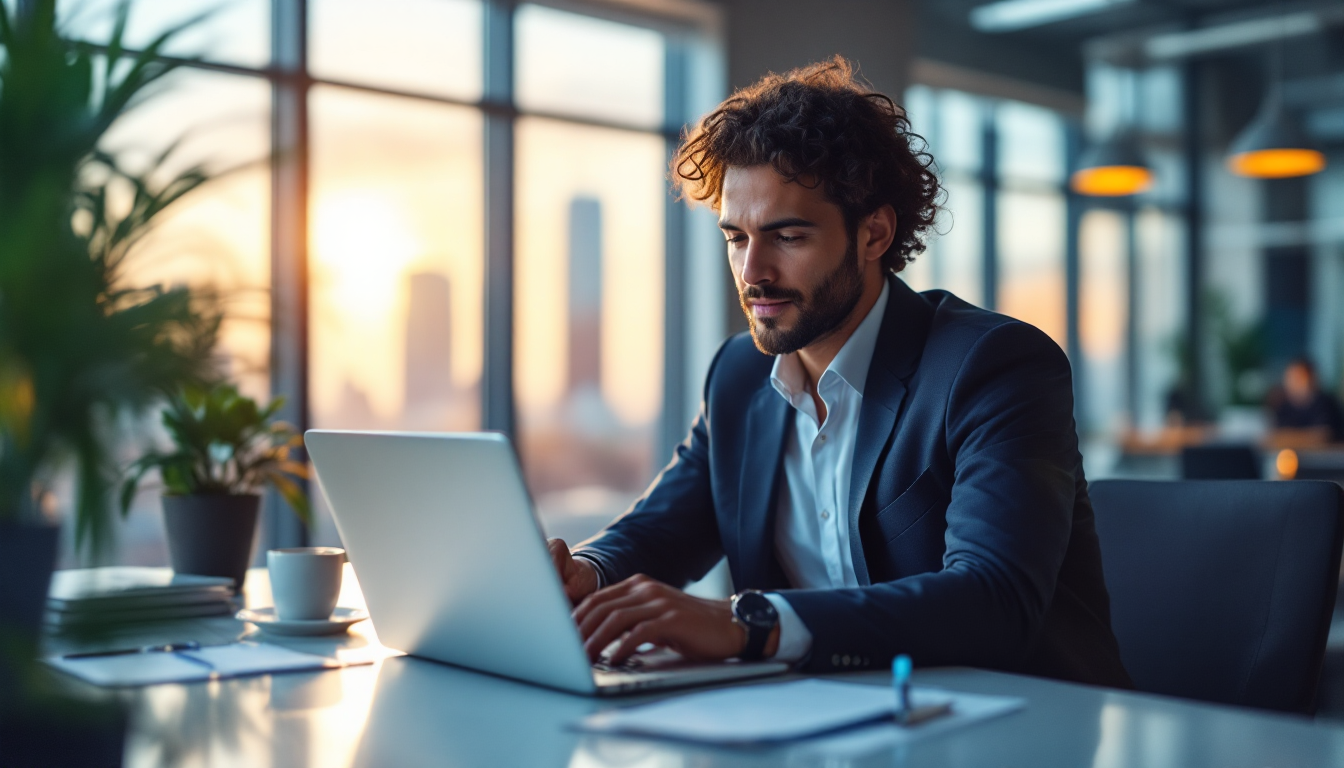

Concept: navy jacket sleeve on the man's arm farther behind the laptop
[[574, 343, 727, 586]]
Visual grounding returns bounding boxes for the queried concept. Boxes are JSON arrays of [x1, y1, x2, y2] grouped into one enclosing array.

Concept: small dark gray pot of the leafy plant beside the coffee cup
[[164, 494, 261, 590]]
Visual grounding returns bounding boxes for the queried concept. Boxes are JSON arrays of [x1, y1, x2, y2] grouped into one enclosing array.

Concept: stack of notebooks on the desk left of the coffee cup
[[46, 566, 234, 629]]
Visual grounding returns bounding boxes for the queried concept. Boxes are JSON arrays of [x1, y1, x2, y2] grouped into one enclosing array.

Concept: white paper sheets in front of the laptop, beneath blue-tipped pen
[[577, 679, 1025, 744]]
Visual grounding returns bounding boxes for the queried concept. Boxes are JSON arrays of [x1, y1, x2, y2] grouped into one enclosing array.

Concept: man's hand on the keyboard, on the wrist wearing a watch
[[574, 574, 780, 664]]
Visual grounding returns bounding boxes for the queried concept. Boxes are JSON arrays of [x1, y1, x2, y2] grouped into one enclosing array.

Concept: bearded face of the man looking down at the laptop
[[719, 165, 864, 355]]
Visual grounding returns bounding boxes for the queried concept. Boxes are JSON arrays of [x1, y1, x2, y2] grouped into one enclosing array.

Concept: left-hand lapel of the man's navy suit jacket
[[734, 379, 790, 589]]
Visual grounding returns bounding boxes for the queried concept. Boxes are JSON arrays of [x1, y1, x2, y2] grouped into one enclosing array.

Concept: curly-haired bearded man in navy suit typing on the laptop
[[550, 58, 1129, 686]]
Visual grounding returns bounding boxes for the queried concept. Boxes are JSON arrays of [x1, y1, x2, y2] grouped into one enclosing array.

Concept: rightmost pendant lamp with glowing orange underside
[[1227, 91, 1325, 179]]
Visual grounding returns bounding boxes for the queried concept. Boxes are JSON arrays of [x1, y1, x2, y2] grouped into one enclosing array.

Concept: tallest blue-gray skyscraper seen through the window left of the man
[[567, 198, 602, 394]]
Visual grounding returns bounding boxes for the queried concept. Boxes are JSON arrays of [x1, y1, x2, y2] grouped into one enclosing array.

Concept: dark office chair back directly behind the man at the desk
[[1089, 480, 1344, 714]]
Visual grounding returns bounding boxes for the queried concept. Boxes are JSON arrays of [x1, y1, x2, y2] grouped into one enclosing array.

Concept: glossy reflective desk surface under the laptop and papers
[[51, 570, 1344, 768]]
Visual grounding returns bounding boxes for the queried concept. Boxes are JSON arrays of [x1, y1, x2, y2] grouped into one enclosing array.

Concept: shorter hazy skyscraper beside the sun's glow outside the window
[[405, 272, 453, 410]]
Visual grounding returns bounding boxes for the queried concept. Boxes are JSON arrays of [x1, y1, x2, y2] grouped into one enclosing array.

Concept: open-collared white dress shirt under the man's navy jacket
[[766, 282, 891, 662]]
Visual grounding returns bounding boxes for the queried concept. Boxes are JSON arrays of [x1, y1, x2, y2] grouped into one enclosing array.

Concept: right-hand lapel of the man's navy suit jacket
[[849, 276, 933, 586]]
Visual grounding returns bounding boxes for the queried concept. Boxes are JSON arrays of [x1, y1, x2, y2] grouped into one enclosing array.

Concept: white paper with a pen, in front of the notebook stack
[[46, 643, 345, 687]]
